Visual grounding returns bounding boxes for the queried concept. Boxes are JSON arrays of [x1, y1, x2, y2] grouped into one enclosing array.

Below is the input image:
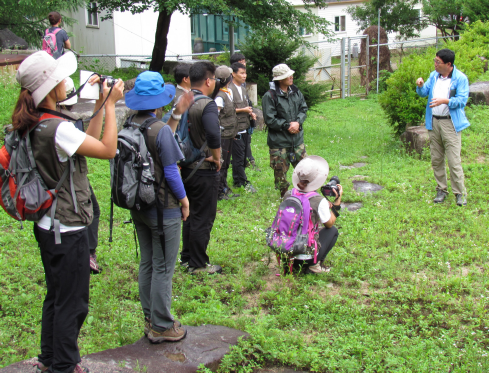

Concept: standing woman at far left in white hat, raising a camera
[[12, 51, 124, 373]]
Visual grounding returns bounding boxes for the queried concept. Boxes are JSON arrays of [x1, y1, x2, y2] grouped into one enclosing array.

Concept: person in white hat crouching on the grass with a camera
[[284, 155, 343, 274]]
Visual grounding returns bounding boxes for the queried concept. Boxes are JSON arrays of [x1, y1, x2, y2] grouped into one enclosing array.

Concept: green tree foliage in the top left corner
[[0, 0, 86, 47]]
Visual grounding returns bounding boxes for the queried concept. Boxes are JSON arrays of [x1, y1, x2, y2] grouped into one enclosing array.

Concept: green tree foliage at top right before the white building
[[347, 0, 427, 39]]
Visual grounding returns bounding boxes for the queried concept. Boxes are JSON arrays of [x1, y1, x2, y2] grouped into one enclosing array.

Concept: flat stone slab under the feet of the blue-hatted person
[[0, 325, 248, 373]]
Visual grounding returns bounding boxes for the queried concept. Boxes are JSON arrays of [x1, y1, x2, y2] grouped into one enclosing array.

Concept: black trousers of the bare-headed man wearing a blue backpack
[[181, 168, 220, 268]]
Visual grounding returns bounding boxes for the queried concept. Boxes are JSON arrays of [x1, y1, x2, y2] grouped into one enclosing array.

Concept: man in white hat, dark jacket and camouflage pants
[[262, 63, 307, 198]]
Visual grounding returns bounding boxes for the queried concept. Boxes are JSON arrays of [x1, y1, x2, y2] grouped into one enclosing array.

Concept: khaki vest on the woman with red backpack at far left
[[31, 118, 93, 227]]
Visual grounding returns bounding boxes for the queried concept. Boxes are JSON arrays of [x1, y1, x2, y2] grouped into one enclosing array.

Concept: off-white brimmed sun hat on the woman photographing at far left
[[15, 51, 78, 107]]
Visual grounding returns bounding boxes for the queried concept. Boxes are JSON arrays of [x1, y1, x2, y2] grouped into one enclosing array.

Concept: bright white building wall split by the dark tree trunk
[[113, 10, 192, 56]]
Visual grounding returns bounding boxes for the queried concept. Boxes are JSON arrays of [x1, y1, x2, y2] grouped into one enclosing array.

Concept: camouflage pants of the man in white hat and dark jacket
[[270, 144, 307, 190]]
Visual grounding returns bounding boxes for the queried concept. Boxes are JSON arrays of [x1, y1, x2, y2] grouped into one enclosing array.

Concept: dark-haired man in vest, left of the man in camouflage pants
[[229, 62, 256, 193]]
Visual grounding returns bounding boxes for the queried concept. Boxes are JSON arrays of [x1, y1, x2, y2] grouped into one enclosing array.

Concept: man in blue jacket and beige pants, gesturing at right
[[416, 49, 470, 206]]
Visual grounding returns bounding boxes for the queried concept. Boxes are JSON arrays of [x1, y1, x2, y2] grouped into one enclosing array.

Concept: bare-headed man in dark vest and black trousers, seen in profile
[[180, 61, 222, 274]]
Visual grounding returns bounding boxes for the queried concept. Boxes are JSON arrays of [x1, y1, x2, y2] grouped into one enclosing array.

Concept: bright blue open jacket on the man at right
[[416, 65, 470, 132]]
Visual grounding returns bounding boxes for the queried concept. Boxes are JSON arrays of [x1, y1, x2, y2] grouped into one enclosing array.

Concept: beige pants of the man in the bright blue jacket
[[428, 117, 465, 195]]
